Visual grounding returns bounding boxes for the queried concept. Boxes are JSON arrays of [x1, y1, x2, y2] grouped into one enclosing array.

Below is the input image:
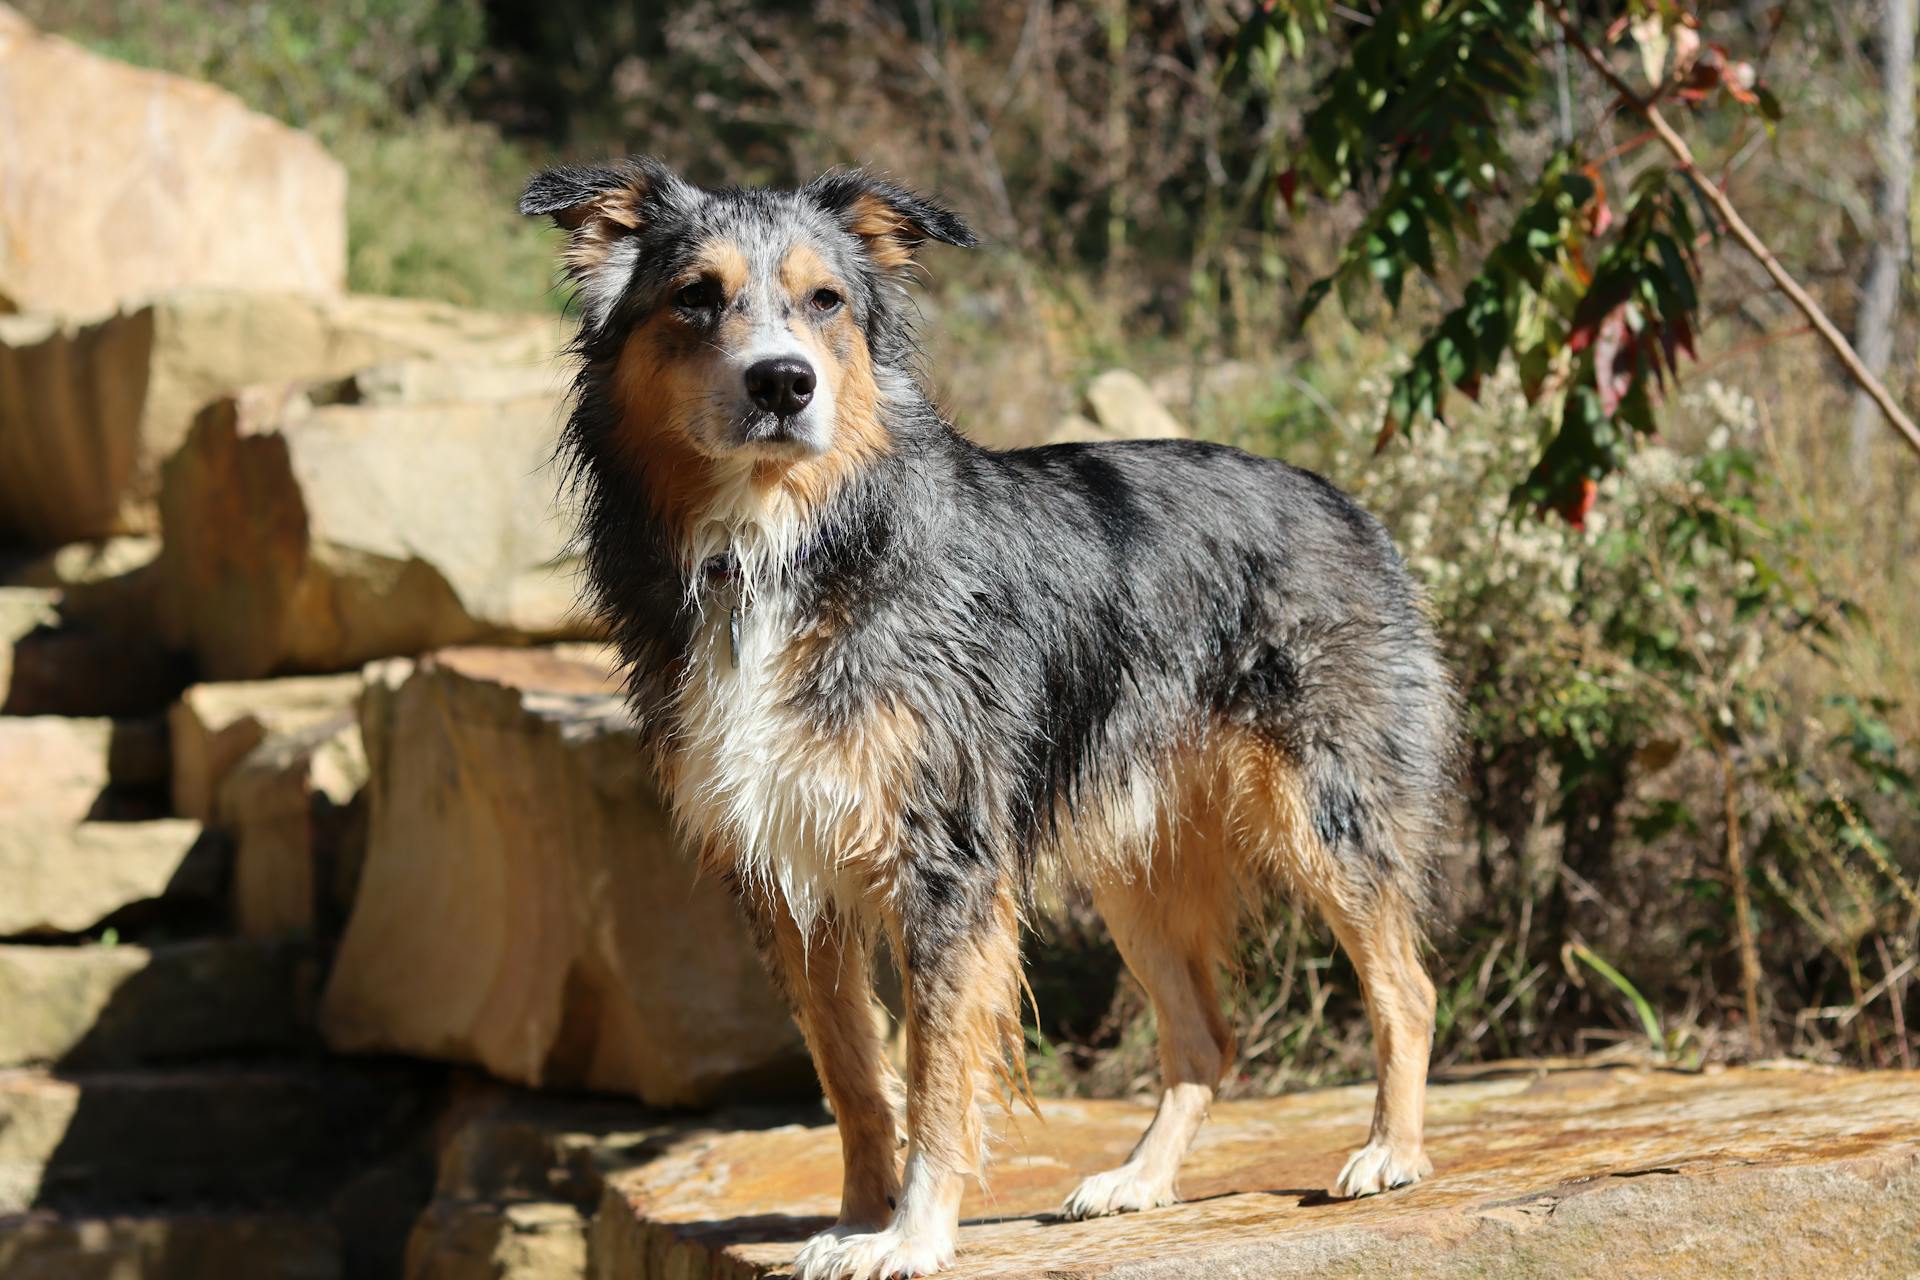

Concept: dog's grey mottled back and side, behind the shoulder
[[898, 439, 1455, 900]]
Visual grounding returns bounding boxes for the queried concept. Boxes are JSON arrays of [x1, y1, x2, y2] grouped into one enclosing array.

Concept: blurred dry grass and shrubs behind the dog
[[21, 0, 1920, 1092]]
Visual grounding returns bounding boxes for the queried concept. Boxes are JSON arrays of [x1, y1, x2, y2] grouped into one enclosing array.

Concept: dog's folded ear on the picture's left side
[[520, 155, 697, 328]]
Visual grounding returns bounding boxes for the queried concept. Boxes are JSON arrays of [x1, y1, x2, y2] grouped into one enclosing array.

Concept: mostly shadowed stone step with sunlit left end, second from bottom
[[0, 1061, 428, 1220]]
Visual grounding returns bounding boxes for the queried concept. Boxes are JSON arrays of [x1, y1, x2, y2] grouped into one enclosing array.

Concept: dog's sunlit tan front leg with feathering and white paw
[[793, 889, 1020, 1280]]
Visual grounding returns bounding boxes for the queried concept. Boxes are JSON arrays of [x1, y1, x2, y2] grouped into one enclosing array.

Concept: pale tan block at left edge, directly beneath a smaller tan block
[[0, 819, 227, 936]]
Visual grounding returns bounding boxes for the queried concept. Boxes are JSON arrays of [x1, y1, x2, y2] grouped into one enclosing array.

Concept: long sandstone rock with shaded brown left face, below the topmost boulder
[[0, 290, 559, 545]]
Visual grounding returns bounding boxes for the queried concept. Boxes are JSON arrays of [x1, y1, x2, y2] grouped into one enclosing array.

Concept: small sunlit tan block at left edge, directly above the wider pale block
[[0, 716, 167, 823]]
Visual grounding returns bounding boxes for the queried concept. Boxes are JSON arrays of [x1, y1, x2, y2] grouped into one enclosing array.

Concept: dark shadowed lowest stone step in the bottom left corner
[[0, 1211, 348, 1280]]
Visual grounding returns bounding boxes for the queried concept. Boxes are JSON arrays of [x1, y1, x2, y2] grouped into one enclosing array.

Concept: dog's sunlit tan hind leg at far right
[[1321, 892, 1434, 1196]]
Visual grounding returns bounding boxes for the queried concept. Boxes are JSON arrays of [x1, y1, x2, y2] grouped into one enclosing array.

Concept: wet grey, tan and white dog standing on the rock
[[520, 159, 1455, 1280]]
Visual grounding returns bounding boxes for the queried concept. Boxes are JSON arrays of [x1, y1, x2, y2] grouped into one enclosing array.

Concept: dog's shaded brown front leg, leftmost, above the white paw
[[749, 902, 900, 1234]]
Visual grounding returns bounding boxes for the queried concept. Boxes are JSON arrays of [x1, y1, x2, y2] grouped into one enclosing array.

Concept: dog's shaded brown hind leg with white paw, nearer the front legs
[[1062, 871, 1238, 1219]]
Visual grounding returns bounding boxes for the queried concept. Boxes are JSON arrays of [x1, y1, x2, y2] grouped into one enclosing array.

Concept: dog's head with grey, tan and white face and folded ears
[[520, 159, 973, 482]]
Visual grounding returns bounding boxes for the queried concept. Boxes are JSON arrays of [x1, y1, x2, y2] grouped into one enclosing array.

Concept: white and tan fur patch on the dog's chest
[[674, 591, 877, 929]]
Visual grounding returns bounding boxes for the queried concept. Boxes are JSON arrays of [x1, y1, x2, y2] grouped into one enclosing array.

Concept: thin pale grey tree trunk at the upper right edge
[[1847, 0, 1920, 495]]
